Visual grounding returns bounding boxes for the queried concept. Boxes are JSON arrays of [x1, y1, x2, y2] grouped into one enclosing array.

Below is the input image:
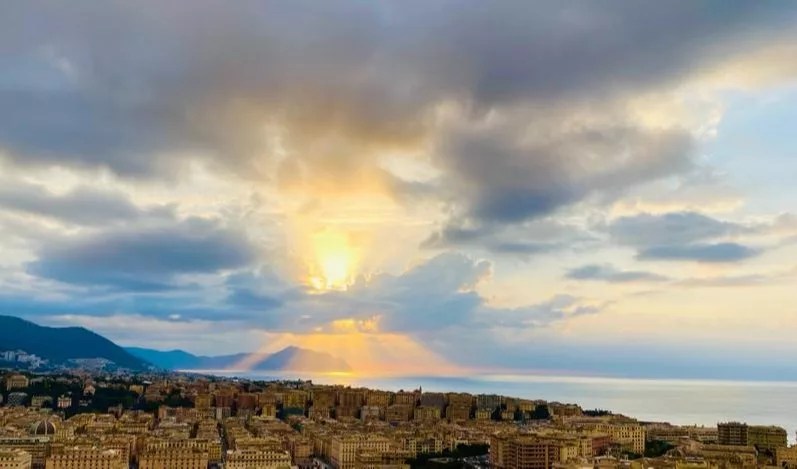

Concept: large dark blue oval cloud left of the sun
[[27, 219, 257, 290]]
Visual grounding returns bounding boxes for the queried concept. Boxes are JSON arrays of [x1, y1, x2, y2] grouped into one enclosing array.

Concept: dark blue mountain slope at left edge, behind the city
[[0, 316, 150, 370]]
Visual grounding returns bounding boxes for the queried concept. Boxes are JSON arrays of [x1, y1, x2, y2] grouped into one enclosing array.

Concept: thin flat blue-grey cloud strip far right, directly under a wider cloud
[[637, 243, 762, 263]]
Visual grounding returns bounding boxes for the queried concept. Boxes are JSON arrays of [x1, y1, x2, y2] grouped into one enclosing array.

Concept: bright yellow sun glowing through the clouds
[[310, 230, 357, 290]]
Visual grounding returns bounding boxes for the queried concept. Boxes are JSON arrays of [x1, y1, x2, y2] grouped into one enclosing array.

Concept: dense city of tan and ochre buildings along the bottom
[[0, 370, 797, 469]]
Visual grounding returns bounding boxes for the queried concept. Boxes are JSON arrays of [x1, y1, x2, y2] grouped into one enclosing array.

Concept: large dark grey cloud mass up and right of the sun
[[440, 125, 693, 223]]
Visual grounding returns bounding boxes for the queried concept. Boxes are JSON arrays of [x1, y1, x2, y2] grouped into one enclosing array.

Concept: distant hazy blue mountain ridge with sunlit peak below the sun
[[125, 347, 351, 373]]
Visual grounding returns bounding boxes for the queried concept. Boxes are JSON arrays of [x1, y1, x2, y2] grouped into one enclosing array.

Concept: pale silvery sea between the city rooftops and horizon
[[202, 372, 797, 444]]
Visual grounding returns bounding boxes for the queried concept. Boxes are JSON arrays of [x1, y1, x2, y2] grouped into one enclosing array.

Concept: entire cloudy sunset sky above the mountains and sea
[[0, 0, 797, 379]]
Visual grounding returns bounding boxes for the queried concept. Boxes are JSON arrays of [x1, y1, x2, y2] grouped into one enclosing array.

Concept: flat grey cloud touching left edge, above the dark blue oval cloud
[[0, 181, 174, 226]]
